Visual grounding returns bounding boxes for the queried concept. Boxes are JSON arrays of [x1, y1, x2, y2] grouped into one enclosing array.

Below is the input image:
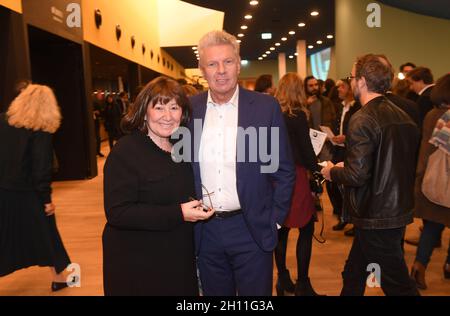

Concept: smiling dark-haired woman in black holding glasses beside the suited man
[[103, 77, 214, 296]]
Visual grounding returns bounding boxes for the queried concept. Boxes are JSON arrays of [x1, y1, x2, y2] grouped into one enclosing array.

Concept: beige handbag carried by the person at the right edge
[[422, 149, 450, 208]]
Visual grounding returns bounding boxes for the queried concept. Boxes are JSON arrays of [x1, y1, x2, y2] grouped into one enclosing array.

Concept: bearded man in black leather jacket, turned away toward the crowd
[[322, 54, 419, 295]]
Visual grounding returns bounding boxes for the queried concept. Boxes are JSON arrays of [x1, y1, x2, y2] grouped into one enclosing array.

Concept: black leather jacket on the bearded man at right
[[331, 96, 419, 229]]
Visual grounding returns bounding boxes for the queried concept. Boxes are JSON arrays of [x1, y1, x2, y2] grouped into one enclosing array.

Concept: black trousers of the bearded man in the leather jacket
[[341, 227, 420, 296]]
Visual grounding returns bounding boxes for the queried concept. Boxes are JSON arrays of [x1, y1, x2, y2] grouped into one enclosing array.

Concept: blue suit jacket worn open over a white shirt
[[189, 88, 295, 253]]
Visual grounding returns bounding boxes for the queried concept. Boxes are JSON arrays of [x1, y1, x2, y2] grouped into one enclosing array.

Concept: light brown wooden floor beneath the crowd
[[0, 145, 450, 296]]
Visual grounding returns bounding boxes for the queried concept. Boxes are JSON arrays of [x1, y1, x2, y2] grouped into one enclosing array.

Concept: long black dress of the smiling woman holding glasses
[[103, 132, 198, 296]]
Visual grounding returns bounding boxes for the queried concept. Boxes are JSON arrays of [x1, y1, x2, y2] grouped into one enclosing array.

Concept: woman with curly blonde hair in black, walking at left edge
[[0, 84, 70, 291]]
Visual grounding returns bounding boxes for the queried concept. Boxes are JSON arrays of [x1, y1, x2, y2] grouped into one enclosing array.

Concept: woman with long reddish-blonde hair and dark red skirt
[[275, 73, 319, 296]]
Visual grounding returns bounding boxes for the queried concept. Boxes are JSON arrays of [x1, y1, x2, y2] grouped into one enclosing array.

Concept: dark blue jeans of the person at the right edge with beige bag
[[416, 219, 450, 266]]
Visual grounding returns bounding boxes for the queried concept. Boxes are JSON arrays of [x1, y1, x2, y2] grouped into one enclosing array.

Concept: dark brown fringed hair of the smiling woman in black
[[121, 77, 191, 134]]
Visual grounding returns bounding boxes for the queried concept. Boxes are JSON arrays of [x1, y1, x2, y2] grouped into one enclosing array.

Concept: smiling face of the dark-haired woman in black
[[147, 99, 183, 138]]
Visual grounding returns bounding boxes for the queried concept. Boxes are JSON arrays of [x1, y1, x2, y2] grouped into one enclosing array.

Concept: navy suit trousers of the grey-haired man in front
[[197, 214, 273, 296]]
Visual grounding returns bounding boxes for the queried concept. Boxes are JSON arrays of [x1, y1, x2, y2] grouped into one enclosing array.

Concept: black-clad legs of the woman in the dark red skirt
[[274, 219, 314, 282]]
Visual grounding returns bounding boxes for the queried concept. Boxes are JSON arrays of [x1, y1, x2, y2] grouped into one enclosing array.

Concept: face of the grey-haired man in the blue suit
[[200, 45, 241, 99]]
